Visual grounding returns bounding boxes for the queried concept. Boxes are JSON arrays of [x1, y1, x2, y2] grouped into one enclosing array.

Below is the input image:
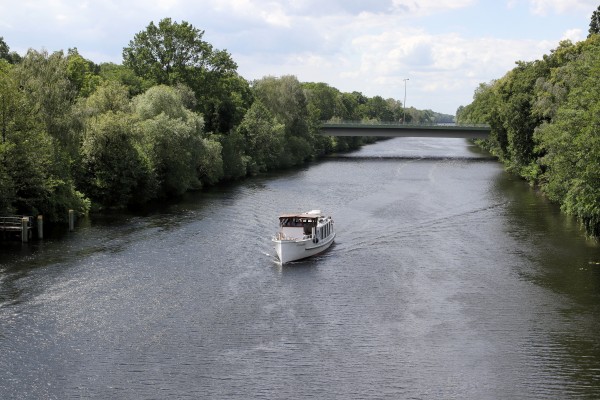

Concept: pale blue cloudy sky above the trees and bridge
[[0, 0, 600, 115]]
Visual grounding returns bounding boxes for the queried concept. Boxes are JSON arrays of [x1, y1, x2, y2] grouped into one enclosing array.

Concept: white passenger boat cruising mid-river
[[273, 210, 335, 264]]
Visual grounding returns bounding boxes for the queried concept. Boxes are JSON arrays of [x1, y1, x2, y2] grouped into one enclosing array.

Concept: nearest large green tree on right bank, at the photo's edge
[[535, 35, 600, 237]]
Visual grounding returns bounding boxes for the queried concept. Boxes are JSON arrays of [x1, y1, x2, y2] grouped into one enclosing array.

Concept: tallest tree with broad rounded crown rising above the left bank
[[123, 18, 245, 133]]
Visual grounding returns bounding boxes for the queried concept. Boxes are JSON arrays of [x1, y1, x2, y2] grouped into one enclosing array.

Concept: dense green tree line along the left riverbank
[[0, 18, 454, 222]]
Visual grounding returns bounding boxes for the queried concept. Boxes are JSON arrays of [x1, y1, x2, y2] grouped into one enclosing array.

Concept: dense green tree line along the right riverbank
[[456, 7, 600, 237]]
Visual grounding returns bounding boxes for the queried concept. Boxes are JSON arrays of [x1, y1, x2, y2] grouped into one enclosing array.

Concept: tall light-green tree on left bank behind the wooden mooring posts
[[5, 50, 89, 221]]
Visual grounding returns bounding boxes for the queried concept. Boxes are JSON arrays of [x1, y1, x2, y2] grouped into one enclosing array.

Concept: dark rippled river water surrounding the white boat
[[0, 138, 600, 399]]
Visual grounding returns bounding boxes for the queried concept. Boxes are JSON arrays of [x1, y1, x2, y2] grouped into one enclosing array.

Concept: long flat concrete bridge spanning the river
[[321, 122, 491, 139]]
